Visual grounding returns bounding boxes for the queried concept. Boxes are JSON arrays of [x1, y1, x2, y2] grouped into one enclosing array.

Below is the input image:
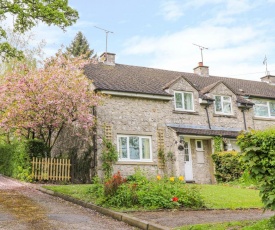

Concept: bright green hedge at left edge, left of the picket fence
[[0, 143, 32, 181]]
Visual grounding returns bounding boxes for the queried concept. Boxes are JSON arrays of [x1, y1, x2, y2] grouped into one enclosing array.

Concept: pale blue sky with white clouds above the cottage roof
[[4, 0, 275, 80]]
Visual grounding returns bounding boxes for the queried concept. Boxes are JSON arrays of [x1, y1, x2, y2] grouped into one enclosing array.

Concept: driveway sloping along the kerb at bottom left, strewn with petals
[[0, 175, 134, 230]]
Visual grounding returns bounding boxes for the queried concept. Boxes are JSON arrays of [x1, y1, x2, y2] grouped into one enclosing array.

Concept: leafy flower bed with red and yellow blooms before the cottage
[[90, 171, 204, 209]]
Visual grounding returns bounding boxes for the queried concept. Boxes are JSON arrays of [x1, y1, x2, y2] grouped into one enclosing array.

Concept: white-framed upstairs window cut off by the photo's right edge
[[254, 100, 275, 118]]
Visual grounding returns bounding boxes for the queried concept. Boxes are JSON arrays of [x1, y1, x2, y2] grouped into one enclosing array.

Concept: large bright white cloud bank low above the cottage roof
[[123, 22, 275, 80]]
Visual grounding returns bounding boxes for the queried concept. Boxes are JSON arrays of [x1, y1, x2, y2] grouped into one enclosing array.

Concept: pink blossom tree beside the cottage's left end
[[0, 52, 101, 153]]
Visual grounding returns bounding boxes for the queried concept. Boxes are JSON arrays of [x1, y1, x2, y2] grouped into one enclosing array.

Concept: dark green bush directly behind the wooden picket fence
[[25, 139, 50, 159]]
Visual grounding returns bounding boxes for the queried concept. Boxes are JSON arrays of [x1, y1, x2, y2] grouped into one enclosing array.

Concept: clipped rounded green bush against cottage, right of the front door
[[212, 151, 243, 182]]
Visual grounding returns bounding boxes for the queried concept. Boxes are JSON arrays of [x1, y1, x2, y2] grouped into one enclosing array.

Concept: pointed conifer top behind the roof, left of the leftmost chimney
[[67, 31, 94, 58]]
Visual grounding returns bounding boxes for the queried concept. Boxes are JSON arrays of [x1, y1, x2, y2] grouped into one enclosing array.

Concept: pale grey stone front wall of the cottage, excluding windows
[[94, 78, 275, 183]]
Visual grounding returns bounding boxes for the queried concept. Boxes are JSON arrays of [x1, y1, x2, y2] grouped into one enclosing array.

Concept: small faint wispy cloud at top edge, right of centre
[[160, 0, 183, 21]]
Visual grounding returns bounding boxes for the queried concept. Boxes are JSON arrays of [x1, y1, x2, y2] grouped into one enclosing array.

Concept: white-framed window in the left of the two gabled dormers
[[174, 91, 194, 111]]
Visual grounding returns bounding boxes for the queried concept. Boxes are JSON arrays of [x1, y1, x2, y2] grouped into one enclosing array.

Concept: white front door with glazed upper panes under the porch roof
[[184, 138, 193, 181]]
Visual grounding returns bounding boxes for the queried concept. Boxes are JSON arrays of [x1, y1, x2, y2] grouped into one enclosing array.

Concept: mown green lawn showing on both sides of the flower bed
[[45, 184, 263, 209]]
